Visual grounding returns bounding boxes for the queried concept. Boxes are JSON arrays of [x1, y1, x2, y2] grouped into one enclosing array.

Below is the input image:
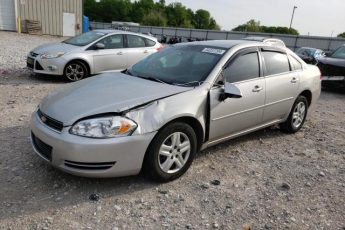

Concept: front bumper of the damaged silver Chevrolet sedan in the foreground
[[31, 113, 156, 177]]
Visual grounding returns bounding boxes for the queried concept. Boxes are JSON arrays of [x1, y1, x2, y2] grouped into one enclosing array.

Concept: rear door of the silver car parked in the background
[[126, 34, 155, 67]]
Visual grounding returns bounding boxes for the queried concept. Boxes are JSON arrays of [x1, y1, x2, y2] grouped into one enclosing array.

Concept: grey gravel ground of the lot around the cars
[[0, 32, 345, 230]]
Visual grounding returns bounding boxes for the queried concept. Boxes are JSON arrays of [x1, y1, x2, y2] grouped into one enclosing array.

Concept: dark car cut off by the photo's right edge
[[317, 44, 345, 89]]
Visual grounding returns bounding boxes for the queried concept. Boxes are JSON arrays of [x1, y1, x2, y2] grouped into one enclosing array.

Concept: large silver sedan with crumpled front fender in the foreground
[[31, 40, 320, 181]]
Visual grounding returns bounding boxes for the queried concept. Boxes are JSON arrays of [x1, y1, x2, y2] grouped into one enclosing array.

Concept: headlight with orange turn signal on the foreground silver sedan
[[69, 116, 138, 138]]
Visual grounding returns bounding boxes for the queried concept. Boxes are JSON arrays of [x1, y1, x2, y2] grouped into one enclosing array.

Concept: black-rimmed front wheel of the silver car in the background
[[63, 61, 89, 82]]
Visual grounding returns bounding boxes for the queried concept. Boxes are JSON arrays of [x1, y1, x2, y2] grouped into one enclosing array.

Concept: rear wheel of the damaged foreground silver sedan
[[280, 95, 308, 133]]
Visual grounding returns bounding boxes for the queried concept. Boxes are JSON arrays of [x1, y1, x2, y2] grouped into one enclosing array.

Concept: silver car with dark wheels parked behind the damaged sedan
[[27, 30, 162, 81]]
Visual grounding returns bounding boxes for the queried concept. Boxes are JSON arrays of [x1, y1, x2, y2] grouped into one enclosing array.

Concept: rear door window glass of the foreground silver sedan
[[262, 51, 290, 76]]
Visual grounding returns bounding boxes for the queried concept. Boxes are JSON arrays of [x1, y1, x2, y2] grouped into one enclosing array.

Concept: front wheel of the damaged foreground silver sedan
[[144, 122, 197, 182]]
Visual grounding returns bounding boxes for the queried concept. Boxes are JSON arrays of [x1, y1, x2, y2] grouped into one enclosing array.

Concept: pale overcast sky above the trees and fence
[[162, 0, 345, 37]]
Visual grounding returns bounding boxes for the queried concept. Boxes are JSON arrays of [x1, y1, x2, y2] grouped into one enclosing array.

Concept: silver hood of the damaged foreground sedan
[[39, 73, 191, 126]]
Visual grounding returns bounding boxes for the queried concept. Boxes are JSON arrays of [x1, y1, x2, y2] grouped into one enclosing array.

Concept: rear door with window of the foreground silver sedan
[[261, 47, 300, 123]]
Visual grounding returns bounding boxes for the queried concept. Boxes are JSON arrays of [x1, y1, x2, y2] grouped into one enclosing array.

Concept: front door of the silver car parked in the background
[[91, 34, 128, 73]]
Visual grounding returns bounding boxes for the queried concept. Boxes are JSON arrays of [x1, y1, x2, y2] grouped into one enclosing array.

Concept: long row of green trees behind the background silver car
[[84, 0, 220, 29]]
